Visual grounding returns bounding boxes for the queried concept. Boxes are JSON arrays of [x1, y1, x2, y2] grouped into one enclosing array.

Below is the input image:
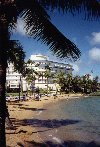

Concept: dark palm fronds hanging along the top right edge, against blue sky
[[38, 0, 100, 19]]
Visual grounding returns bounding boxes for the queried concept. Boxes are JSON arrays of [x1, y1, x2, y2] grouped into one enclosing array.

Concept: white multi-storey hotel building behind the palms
[[6, 54, 73, 91]]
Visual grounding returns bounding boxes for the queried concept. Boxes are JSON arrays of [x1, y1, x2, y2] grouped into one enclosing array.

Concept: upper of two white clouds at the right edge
[[90, 32, 100, 45]]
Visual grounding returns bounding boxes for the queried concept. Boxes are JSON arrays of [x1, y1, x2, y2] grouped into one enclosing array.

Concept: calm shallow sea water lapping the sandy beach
[[36, 97, 100, 147]]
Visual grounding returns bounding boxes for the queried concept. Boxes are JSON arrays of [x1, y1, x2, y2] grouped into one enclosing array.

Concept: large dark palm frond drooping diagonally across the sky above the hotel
[[16, 0, 80, 60]]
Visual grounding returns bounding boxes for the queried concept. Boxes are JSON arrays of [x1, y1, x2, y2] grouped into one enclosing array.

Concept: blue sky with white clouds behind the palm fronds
[[11, 11, 100, 77]]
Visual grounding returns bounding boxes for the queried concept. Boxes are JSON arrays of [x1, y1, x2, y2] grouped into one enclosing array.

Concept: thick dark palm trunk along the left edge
[[0, 22, 8, 147]]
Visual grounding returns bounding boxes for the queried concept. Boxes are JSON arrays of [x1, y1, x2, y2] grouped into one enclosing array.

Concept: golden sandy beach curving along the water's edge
[[6, 94, 82, 147]]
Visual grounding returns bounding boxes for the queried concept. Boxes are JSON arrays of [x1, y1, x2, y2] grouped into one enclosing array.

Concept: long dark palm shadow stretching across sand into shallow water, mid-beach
[[14, 119, 80, 128]]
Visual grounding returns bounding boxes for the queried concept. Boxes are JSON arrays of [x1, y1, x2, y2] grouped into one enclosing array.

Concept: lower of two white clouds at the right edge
[[89, 47, 100, 61]]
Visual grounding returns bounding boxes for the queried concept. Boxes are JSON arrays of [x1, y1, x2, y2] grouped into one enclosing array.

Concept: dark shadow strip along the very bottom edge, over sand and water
[[17, 141, 100, 147]]
